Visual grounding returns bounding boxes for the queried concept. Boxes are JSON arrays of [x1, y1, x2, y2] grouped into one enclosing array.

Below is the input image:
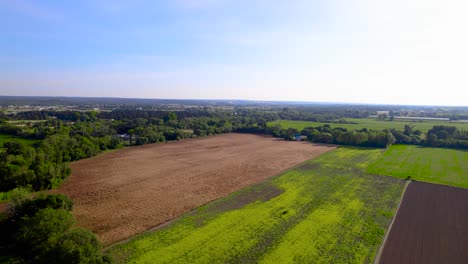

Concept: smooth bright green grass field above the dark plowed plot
[[367, 145, 468, 188]]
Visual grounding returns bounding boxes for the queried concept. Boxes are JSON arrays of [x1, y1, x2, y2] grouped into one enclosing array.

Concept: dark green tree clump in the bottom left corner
[[0, 189, 112, 264]]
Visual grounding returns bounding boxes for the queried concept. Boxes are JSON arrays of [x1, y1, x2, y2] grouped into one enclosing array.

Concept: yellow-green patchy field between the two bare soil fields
[[108, 147, 405, 263]]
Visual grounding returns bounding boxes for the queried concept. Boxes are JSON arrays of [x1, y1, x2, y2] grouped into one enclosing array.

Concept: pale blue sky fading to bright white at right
[[0, 0, 468, 105]]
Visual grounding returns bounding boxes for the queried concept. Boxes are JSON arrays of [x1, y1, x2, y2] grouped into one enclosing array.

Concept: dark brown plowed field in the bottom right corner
[[380, 182, 468, 264]]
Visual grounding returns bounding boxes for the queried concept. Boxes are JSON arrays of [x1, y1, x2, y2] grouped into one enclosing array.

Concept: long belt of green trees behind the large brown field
[[0, 108, 468, 191]]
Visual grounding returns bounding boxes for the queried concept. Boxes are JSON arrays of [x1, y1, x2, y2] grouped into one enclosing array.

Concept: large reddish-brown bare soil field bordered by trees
[[58, 134, 335, 245]]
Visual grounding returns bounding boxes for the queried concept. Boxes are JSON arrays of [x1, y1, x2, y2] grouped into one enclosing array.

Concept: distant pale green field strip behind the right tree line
[[268, 118, 468, 132]]
